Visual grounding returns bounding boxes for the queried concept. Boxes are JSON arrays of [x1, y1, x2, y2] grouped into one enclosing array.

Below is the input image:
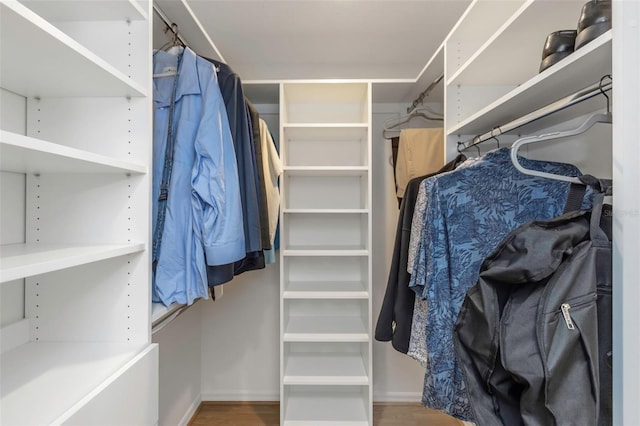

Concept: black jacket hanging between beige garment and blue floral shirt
[[375, 155, 466, 354]]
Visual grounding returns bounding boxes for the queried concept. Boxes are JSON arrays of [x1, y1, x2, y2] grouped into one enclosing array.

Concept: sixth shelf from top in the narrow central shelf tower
[[284, 316, 369, 342]]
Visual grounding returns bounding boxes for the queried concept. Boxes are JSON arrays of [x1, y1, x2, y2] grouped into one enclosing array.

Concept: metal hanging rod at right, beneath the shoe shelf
[[458, 77, 613, 151]]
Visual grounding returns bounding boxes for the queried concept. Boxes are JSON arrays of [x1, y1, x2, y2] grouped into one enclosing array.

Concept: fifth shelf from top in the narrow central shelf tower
[[283, 281, 369, 299]]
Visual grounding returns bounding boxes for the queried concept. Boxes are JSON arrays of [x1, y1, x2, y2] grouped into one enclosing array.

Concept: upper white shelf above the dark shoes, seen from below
[[447, 0, 584, 86]]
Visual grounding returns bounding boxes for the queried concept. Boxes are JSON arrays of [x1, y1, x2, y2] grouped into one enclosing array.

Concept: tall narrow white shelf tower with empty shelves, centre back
[[280, 82, 372, 426]]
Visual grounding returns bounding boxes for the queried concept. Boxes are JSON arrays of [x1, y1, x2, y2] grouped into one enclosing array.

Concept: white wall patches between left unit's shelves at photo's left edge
[[0, 88, 27, 326]]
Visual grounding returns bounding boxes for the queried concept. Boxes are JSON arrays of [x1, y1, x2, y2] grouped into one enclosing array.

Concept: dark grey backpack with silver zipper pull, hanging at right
[[455, 177, 612, 426]]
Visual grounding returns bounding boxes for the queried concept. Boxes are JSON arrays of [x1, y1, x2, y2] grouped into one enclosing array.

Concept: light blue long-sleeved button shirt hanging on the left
[[152, 48, 245, 305]]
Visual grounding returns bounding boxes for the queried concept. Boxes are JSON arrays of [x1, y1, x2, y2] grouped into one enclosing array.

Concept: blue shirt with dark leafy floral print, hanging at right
[[409, 148, 589, 420]]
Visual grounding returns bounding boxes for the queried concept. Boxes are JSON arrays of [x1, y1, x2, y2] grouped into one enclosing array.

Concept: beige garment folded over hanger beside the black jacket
[[396, 127, 445, 198]]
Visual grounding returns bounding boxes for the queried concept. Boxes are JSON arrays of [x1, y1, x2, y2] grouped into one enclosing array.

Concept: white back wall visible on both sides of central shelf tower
[[199, 104, 424, 401]]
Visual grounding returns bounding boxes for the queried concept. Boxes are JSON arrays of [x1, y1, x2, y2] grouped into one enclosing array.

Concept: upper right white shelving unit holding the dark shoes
[[445, 0, 612, 159]]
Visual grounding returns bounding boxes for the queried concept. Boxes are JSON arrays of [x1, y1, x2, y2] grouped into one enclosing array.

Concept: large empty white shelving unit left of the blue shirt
[[0, 0, 158, 425]]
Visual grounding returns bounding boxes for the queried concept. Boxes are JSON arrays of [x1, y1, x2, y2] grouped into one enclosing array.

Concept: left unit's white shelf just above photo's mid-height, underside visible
[[0, 130, 147, 174]]
